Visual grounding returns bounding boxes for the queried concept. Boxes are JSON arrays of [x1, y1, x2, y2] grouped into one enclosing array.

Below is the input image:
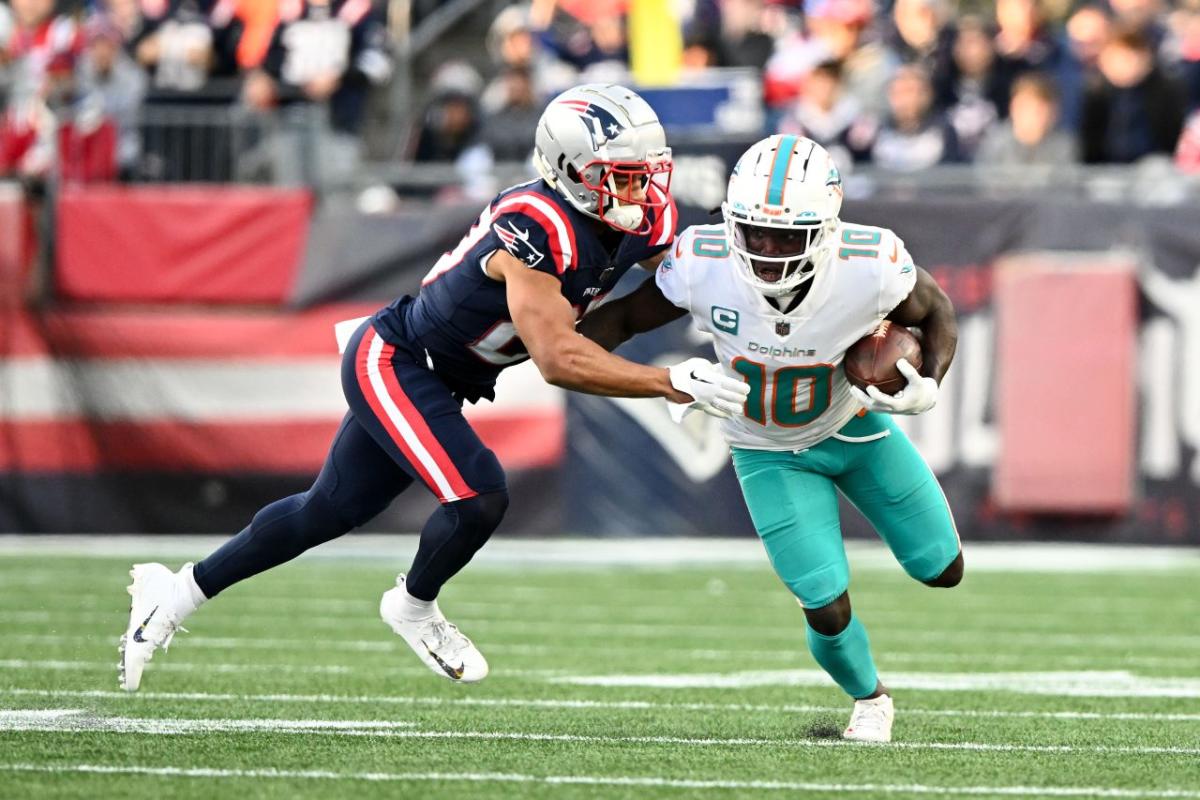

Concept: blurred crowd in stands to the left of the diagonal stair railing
[[0, 0, 392, 180]]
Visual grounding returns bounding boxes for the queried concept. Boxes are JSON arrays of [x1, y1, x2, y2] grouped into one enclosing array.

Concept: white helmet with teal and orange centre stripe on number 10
[[721, 134, 841, 297]]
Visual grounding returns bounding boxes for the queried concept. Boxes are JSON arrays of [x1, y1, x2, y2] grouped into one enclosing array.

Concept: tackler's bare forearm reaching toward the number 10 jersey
[[533, 336, 691, 403]]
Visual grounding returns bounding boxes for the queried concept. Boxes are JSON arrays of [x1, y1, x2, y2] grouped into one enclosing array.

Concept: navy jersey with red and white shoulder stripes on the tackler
[[374, 180, 677, 401]]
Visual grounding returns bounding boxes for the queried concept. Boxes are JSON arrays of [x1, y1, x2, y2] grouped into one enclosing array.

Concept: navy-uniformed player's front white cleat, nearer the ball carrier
[[379, 575, 487, 684]]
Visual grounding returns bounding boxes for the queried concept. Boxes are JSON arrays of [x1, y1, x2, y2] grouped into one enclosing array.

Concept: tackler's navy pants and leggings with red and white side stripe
[[193, 321, 508, 600]]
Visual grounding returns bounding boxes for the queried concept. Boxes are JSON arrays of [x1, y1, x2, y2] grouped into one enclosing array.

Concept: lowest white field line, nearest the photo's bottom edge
[[0, 764, 1200, 800]]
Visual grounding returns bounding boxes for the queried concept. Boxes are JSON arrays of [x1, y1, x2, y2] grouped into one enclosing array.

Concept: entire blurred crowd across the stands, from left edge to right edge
[[7, 0, 1200, 188]]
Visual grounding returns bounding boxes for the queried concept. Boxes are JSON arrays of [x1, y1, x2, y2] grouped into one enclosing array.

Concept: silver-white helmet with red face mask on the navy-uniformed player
[[533, 84, 672, 234]]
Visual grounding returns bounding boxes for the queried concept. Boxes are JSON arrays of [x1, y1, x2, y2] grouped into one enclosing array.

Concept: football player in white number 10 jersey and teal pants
[[580, 136, 962, 741]]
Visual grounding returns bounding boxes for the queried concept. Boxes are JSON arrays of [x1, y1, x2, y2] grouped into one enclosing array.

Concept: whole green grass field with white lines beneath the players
[[0, 540, 1200, 800]]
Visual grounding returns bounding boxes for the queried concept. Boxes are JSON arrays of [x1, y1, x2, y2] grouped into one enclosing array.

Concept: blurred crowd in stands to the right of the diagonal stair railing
[[415, 0, 1200, 177]]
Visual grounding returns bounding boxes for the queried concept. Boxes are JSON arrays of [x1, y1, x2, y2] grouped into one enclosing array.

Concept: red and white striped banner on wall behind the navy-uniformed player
[[0, 306, 565, 474]]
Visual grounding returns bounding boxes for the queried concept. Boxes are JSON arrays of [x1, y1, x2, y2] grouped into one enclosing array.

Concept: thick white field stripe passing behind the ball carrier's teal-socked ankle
[[548, 669, 1200, 698]]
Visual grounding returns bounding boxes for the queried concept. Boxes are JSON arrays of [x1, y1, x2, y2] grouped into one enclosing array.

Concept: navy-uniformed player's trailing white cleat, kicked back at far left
[[118, 564, 193, 692]]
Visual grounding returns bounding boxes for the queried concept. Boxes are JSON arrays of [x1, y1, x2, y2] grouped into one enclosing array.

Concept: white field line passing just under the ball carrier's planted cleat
[[0, 709, 1200, 756]]
